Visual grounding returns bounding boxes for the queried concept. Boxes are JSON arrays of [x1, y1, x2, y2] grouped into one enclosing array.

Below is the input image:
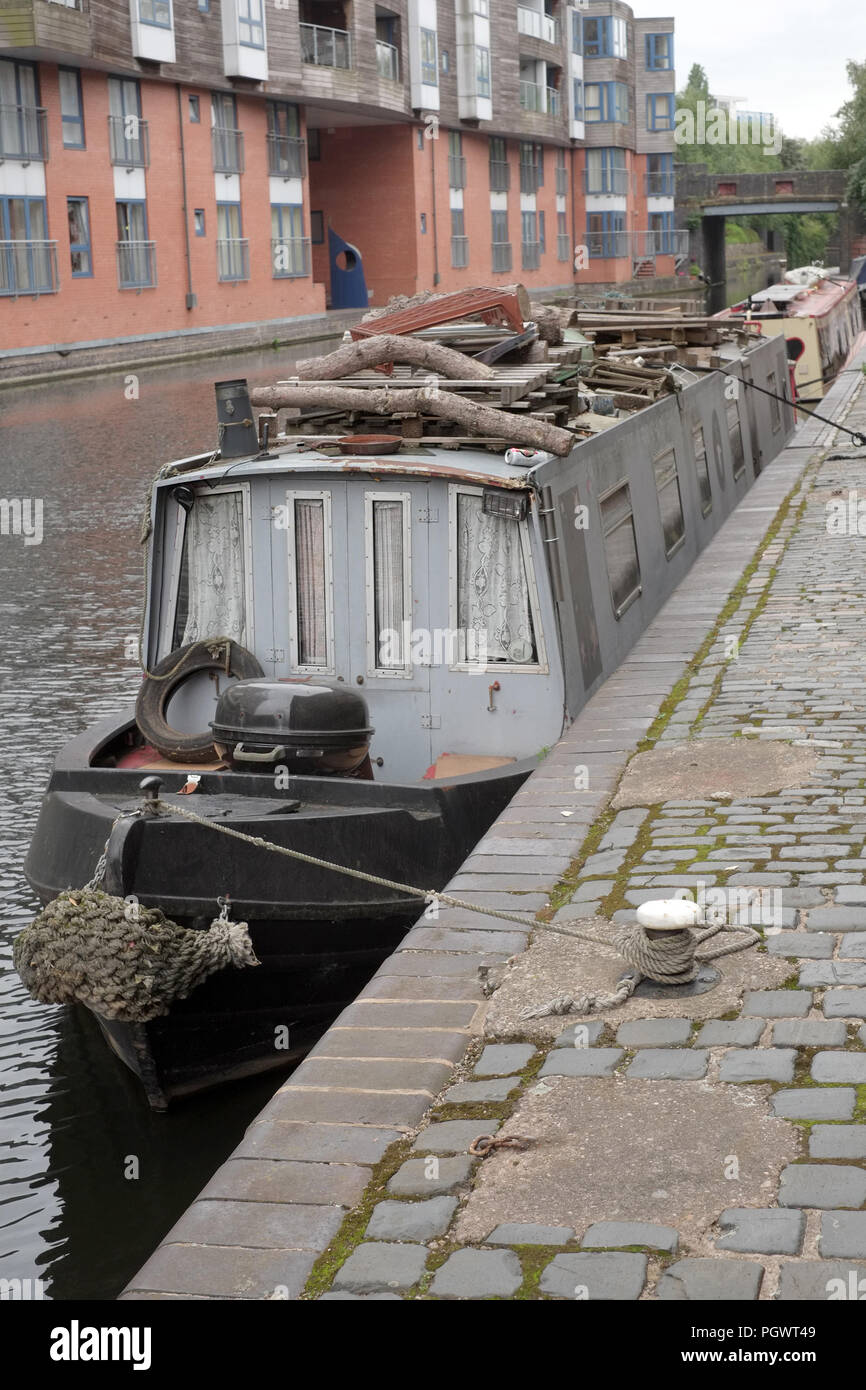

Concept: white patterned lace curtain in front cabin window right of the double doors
[[457, 493, 537, 666]]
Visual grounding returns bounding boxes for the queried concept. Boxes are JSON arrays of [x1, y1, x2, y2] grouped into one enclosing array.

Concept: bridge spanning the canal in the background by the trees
[[676, 164, 866, 313]]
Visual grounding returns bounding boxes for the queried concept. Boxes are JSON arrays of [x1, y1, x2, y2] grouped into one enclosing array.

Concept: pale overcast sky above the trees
[[630, 0, 866, 139]]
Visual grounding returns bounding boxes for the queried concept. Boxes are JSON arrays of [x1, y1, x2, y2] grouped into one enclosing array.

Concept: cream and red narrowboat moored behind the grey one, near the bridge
[[714, 265, 863, 400]]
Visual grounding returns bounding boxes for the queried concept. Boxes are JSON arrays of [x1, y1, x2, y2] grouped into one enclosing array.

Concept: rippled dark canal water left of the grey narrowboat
[[0, 345, 327, 1300]]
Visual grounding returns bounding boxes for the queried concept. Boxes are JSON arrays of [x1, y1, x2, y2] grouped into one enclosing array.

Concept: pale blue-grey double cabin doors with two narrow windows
[[271, 475, 432, 781]]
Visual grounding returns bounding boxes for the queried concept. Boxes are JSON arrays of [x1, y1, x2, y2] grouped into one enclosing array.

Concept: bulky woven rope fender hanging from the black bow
[[13, 887, 259, 1023]]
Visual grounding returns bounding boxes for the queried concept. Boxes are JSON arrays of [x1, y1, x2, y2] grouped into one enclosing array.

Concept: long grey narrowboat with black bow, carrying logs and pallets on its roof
[[17, 307, 794, 1108]]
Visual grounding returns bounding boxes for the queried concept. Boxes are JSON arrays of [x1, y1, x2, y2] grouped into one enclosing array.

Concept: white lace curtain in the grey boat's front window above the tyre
[[181, 492, 246, 646]]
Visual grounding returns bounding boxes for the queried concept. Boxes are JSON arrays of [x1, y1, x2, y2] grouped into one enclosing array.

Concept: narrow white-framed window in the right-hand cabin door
[[364, 492, 411, 676]]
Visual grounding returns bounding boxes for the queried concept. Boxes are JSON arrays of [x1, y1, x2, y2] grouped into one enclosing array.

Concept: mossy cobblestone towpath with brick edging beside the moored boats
[[124, 350, 866, 1301]]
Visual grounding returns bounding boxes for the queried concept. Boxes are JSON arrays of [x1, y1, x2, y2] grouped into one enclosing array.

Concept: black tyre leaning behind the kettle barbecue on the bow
[[135, 638, 264, 763]]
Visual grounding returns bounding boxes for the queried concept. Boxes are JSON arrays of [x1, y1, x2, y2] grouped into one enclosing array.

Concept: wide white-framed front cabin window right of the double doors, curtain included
[[450, 488, 541, 670]]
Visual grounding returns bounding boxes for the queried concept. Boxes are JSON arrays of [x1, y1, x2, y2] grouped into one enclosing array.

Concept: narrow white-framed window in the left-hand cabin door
[[286, 492, 334, 674]]
